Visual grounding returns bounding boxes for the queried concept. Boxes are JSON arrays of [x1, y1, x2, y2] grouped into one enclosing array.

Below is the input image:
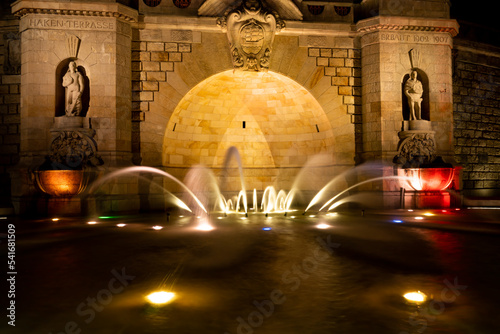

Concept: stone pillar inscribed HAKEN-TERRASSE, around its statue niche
[[11, 0, 138, 212]]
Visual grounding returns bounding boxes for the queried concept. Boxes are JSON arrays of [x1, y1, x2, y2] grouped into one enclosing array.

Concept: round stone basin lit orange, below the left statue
[[35, 170, 87, 196]]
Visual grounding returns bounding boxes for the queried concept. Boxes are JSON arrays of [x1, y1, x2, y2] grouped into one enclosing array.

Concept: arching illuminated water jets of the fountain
[[87, 147, 458, 224]]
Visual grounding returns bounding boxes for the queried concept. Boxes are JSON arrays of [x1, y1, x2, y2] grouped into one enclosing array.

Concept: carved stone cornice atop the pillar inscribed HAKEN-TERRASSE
[[12, 0, 138, 22]]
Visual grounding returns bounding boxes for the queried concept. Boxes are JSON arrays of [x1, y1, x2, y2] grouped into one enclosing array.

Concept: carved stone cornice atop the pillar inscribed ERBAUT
[[356, 16, 459, 37]]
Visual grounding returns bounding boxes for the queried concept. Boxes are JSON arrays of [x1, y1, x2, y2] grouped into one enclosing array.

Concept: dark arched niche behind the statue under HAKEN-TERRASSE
[[55, 58, 90, 117]]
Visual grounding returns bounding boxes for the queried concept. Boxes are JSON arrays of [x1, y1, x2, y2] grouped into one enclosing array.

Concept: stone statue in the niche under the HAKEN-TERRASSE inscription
[[62, 61, 85, 116]]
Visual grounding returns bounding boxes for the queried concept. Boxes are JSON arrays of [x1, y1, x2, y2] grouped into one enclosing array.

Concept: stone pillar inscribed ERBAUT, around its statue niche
[[357, 16, 458, 206]]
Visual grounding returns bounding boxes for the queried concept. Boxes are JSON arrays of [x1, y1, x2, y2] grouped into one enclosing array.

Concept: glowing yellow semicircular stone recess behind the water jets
[[163, 70, 334, 168]]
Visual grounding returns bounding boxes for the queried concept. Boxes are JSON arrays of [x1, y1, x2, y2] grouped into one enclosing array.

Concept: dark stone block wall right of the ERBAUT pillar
[[453, 40, 500, 196]]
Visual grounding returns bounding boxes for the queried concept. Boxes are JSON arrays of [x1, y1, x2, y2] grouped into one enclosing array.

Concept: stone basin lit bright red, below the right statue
[[398, 168, 455, 191]]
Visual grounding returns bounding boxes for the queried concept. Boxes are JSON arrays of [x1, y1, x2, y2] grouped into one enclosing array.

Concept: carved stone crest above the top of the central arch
[[217, 0, 285, 71]]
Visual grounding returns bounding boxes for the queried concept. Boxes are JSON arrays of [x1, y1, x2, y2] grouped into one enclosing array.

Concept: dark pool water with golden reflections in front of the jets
[[2, 216, 500, 334]]
